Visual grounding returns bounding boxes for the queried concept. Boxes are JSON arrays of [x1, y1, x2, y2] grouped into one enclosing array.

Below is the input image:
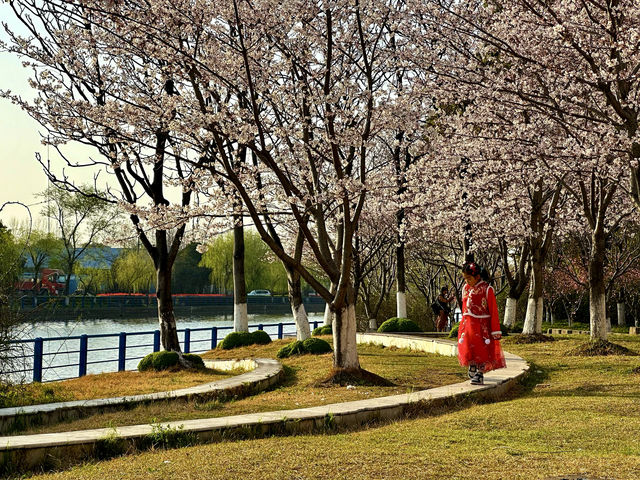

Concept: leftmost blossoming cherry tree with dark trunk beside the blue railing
[[2, 0, 206, 352]]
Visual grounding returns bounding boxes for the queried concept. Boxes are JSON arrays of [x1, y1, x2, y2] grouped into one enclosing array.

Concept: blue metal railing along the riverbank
[[3, 321, 320, 382]]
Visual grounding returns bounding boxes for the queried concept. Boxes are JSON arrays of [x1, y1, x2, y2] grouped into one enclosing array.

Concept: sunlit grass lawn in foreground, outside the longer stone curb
[[13, 335, 640, 480]]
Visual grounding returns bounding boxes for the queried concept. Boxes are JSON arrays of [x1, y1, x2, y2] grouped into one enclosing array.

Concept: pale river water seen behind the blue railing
[[11, 313, 323, 382]]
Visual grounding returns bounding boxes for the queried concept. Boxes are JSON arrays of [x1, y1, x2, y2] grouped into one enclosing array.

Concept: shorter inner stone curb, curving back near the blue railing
[[0, 358, 284, 436]]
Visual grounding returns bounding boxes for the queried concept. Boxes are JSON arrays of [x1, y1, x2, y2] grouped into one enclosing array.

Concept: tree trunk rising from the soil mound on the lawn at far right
[[589, 229, 608, 340]]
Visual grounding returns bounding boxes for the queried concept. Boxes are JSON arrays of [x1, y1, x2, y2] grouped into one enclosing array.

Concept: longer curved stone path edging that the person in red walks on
[[0, 333, 529, 471]]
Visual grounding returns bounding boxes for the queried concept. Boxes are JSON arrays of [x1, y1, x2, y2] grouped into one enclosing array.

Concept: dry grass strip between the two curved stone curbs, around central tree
[[15, 340, 466, 433]]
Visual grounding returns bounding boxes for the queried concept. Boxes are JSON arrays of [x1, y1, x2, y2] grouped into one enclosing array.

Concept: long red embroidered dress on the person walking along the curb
[[458, 280, 506, 372]]
